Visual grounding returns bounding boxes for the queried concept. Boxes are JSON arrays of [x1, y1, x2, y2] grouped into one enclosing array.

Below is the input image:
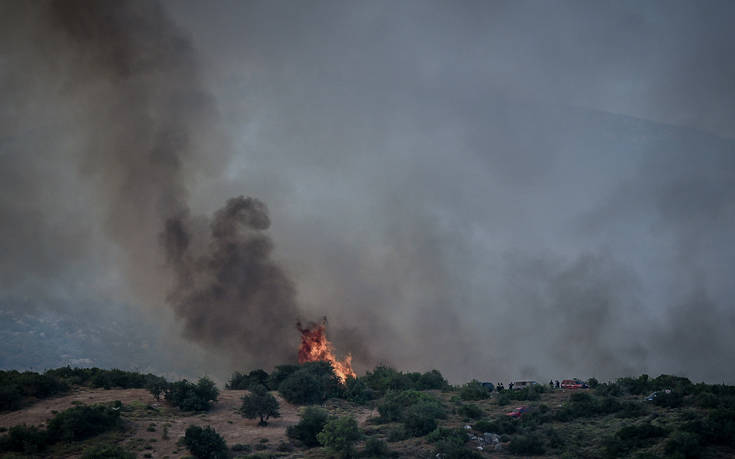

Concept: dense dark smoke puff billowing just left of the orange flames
[[162, 196, 298, 364]]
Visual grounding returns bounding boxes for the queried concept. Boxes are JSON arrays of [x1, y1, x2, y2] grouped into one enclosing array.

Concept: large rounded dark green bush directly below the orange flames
[[278, 362, 343, 405]]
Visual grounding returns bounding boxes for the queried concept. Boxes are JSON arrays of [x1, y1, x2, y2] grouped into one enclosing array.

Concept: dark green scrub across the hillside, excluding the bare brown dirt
[[0, 362, 735, 459]]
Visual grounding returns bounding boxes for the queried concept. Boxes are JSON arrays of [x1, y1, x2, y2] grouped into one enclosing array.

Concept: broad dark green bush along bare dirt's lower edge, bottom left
[[46, 405, 120, 441]]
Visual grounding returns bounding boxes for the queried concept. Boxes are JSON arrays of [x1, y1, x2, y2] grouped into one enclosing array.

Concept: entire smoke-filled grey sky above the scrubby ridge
[[0, 0, 735, 383]]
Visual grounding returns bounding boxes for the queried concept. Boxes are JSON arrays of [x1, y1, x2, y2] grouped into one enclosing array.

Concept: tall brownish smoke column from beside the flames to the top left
[[0, 0, 299, 364]]
